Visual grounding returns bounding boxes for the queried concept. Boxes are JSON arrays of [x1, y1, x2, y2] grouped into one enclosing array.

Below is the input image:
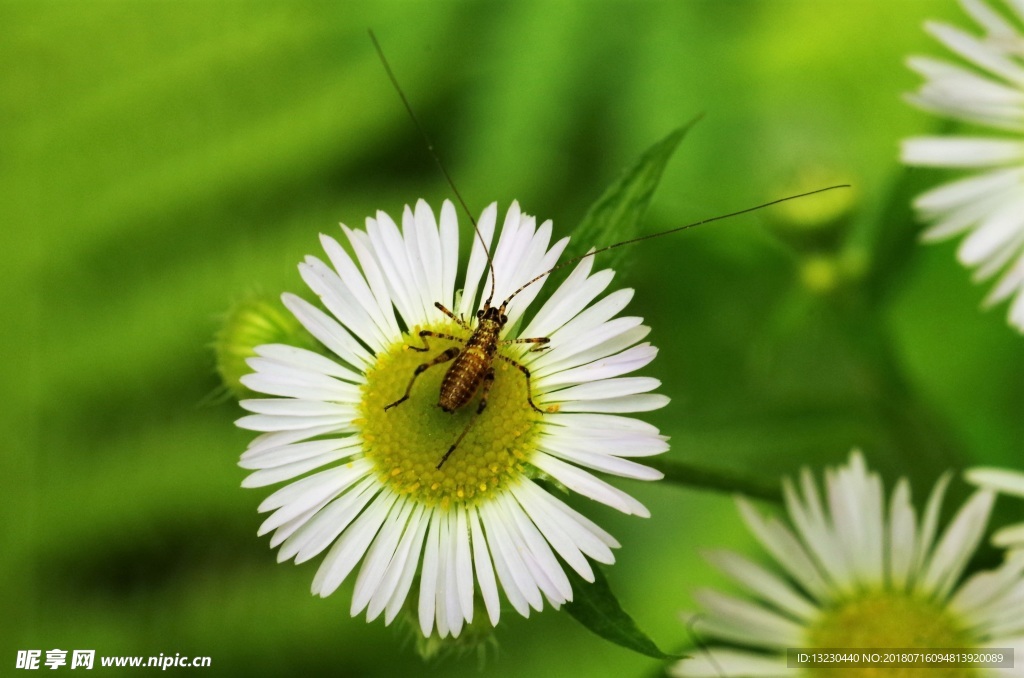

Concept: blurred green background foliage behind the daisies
[[0, 0, 1024, 676]]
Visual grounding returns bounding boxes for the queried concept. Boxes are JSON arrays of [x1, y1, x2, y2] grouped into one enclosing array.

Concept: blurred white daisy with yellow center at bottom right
[[672, 452, 1024, 678]]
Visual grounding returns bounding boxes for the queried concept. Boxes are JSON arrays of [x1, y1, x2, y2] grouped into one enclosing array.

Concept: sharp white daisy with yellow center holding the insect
[[238, 201, 668, 638]]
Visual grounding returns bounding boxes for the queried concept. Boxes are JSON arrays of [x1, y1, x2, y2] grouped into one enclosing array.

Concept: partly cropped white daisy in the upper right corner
[[902, 0, 1024, 331]]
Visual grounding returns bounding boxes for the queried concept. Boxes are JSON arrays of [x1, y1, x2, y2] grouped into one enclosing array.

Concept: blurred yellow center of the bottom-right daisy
[[805, 591, 979, 678]]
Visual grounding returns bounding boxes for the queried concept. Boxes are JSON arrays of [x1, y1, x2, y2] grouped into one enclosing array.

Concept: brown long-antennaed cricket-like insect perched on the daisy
[[370, 31, 846, 470]]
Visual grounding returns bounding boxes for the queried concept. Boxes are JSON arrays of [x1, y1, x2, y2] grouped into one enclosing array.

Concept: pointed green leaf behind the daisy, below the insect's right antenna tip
[[564, 116, 700, 267]]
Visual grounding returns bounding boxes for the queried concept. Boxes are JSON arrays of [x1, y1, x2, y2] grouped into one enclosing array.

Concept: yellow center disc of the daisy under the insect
[[357, 324, 542, 508]]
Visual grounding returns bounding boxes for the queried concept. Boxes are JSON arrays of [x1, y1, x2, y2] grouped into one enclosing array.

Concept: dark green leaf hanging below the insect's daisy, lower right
[[565, 567, 681, 660]]
